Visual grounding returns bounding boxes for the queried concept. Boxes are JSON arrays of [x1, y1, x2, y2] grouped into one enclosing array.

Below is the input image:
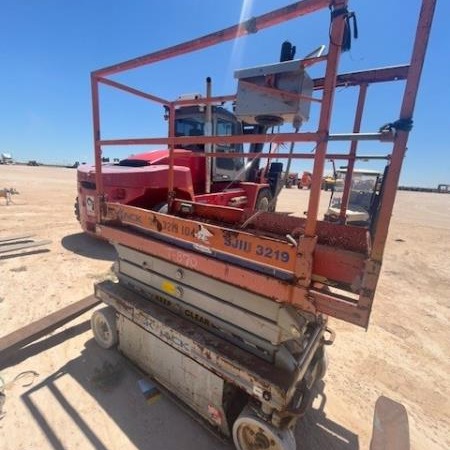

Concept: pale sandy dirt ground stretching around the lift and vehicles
[[0, 166, 450, 450]]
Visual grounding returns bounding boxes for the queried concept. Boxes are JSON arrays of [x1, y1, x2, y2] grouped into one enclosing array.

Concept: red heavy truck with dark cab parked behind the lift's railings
[[75, 103, 282, 234]]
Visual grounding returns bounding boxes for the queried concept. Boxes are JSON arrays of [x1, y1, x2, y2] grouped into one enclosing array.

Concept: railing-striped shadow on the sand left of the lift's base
[[21, 339, 230, 450]]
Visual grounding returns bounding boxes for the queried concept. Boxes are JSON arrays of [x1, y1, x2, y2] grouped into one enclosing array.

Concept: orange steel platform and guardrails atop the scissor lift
[[91, 0, 436, 327]]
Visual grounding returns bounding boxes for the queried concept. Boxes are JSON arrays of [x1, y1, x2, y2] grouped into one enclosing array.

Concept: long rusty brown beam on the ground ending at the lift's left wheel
[[0, 295, 100, 357]]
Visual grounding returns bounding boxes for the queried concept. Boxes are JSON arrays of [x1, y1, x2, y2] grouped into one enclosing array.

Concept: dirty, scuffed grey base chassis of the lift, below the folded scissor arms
[[93, 282, 331, 449]]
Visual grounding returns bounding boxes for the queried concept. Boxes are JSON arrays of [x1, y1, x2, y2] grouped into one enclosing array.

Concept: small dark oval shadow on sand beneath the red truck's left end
[[61, 233, 116, 261]]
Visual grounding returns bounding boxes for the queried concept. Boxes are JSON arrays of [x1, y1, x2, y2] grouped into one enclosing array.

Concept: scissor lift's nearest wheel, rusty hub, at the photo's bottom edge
[[233, 407, 296, 450]]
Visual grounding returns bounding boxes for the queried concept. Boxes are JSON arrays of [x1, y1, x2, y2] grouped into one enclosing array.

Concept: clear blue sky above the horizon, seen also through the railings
[[0, 0, 450, 186]]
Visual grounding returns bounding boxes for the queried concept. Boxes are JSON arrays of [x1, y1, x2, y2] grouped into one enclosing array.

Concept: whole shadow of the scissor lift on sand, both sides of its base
[[22, 339, 359, 450]]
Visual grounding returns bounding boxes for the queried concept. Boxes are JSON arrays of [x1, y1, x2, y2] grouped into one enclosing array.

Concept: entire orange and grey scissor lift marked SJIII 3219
[[91, 0, 435, 449]]
